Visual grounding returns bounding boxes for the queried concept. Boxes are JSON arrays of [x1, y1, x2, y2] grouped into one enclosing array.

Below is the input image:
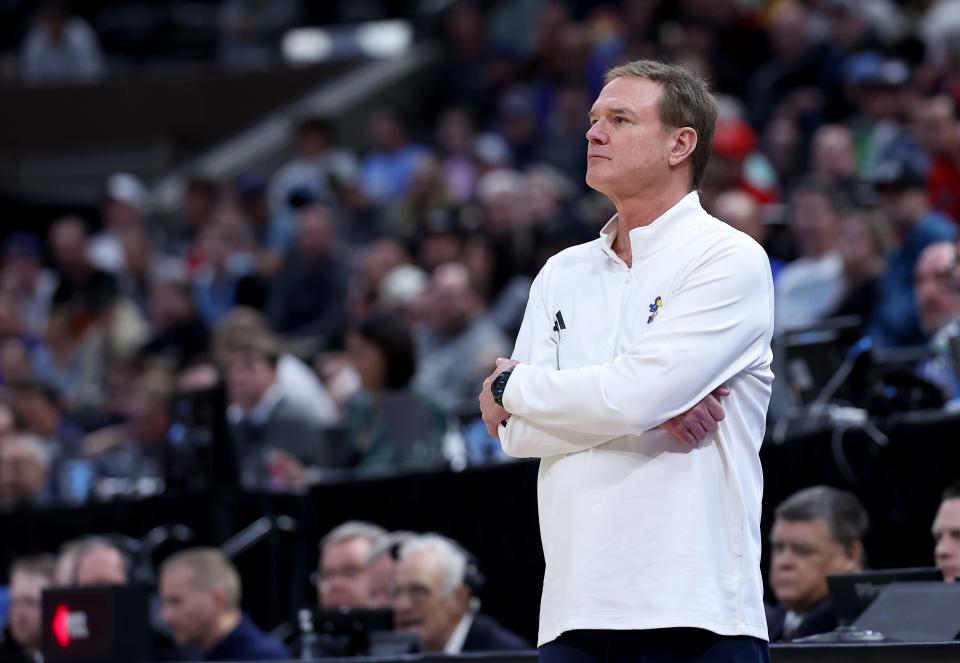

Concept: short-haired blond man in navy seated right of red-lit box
[[160, 548, 290, 661]]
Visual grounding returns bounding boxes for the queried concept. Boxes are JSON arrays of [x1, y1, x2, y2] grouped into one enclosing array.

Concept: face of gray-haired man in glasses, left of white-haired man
[[317, 537, 370, 608]]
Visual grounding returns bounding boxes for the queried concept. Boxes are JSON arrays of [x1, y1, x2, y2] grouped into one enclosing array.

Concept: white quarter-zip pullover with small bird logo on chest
[[500, 192, 773, 645]]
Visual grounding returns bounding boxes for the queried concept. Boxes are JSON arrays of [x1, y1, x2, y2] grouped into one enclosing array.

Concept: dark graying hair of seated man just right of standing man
[[774, 486, 870, 547]]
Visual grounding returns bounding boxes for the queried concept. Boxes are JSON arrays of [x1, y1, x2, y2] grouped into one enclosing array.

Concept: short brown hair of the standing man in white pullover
[[603, 60, 718, 190]]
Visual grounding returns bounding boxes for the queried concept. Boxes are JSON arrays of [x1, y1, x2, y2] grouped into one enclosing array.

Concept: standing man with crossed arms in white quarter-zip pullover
[[480, 61, 773, 663]]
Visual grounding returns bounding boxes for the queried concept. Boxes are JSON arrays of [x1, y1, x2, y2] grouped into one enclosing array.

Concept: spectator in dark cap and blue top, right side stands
[[870, 161, 957, 347]]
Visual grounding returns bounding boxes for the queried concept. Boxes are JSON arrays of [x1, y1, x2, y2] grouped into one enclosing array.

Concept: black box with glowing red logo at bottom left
[[42, 585, 153, 663]]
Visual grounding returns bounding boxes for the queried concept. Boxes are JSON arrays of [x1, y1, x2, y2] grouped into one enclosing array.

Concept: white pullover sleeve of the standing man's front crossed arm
[[503, 241, 773, 438]]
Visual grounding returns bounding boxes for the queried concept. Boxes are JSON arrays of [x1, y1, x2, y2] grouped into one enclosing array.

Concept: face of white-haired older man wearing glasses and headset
[[393, 550, 469, 651]]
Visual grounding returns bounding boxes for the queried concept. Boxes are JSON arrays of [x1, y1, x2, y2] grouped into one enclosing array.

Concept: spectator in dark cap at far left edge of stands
[[0, 233, 57, 336]]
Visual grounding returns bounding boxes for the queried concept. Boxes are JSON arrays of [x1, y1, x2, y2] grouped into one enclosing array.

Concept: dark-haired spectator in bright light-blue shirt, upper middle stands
[[360, 108, 427, 204]]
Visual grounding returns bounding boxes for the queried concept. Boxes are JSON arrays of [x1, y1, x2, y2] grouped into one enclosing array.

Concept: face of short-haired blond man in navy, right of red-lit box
[[160, 566, 221, 645]]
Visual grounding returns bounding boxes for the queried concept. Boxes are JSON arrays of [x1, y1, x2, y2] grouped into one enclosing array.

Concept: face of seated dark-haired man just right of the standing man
[[770, 518, 860, 614]]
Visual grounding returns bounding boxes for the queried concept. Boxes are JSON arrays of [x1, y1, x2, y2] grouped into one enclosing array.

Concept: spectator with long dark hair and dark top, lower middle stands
[[344, 313, 446, 470]]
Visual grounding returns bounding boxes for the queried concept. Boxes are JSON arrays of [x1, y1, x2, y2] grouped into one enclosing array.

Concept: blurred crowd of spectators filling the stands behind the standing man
[[0, 0, 960, 508]]
